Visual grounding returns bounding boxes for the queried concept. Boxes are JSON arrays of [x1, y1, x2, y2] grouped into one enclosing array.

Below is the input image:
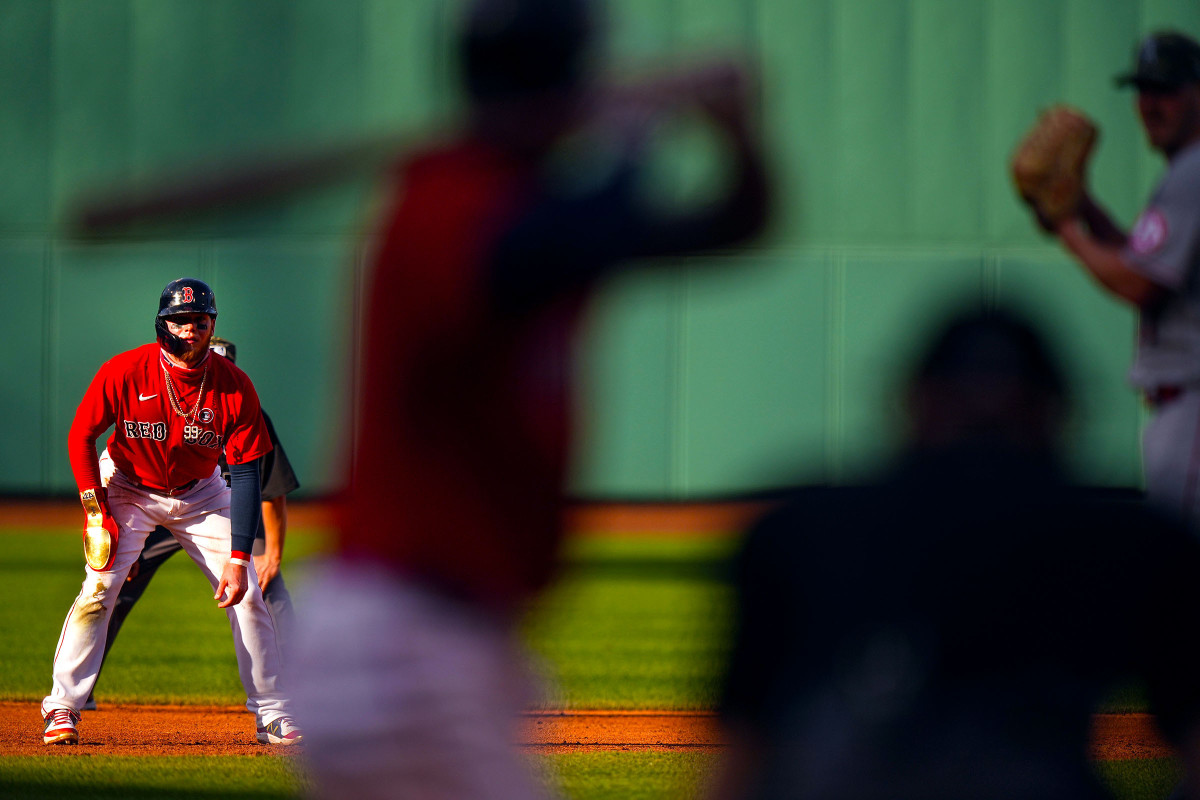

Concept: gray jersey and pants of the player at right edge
[[1123, 143, 1200, 525]]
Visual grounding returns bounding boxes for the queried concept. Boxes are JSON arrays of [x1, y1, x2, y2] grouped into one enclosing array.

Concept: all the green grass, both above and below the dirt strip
[[0, 531, 1176, 800]]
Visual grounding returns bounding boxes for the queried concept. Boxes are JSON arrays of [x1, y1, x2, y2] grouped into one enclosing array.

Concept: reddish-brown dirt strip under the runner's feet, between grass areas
[[0, 702, 1171, 760]]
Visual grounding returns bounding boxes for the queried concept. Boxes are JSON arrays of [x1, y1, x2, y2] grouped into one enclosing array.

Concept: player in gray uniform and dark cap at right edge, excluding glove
[[1052, 31, 1200, 531]]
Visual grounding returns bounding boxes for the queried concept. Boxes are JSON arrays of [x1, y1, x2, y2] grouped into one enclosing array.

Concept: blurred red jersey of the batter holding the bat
[[340, 143, 580, 608]]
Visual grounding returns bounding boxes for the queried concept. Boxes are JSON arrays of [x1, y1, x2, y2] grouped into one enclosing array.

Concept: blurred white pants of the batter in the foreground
[[294, 564, 545, 800]]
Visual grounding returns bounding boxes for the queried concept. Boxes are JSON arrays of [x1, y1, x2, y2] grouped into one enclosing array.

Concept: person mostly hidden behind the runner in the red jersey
[[84, 337, 300, 710]]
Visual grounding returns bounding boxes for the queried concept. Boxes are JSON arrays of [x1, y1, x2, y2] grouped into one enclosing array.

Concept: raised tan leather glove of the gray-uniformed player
[[1009, 106, 1097, 230]]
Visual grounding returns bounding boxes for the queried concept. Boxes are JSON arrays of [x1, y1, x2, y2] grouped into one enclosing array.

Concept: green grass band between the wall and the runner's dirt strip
[[0, 531, 728, 709]]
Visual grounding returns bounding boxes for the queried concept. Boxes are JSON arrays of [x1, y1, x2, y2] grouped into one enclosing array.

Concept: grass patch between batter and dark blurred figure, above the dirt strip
[[527, 537, 730, 710]]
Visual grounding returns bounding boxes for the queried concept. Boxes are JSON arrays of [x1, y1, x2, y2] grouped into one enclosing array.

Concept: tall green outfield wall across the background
[[0, 0, 1200, 498]]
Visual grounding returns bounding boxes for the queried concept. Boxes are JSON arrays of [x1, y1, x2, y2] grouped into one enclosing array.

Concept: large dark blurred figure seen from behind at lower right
[[715, 312, 1200, 800]]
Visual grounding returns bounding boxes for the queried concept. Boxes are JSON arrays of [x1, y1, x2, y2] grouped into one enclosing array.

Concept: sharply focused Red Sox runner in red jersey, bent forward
[[42, 278, 301, 745]]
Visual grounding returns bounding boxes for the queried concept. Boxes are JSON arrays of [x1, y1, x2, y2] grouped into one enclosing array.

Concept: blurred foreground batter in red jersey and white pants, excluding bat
[[296, 0, 767, 798]]
